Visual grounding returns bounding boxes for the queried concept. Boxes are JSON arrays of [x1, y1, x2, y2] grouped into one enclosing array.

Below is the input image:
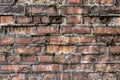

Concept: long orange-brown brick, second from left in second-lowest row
[[33, 64, 60, 71]]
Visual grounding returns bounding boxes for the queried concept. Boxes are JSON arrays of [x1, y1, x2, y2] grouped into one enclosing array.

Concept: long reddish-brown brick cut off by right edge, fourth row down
[[94, 27, 120, 34]]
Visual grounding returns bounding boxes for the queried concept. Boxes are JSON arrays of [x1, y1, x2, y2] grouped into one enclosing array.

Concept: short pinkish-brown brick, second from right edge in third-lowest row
[[98, 55, 113, 63]]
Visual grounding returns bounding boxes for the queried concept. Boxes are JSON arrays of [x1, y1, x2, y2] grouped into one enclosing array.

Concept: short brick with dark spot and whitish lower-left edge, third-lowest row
[[82, 55, 97, 63]]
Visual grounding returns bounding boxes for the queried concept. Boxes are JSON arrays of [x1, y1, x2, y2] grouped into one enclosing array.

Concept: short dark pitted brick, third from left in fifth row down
[[32, 36, 46, 44]]
